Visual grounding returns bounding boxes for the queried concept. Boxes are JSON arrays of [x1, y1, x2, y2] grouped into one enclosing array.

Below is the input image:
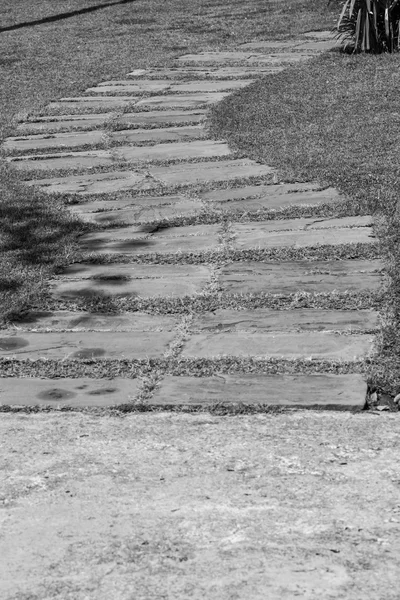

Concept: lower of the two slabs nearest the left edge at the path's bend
[[7, 150, 115, 171]]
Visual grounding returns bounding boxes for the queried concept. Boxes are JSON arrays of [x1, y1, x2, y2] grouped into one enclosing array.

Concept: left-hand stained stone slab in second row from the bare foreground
[[0, 331, 175, 360]]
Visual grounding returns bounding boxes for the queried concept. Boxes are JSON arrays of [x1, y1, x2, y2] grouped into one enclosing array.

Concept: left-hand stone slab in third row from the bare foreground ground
[[12, 310, 179, 332]]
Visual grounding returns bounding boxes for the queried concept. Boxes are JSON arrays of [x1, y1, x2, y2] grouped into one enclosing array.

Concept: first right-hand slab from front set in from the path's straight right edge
[[199, 183, 341, 212]]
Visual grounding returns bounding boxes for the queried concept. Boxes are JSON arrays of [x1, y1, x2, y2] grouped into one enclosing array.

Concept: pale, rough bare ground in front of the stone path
[[0, 412, 400, 600]]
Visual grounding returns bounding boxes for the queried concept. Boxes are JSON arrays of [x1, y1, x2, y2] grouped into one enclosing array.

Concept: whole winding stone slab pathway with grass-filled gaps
[[0, 32, 382, 409]]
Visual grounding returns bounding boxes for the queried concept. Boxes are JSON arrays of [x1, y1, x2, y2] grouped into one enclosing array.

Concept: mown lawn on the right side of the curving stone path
[[212, 52, 400, 393]]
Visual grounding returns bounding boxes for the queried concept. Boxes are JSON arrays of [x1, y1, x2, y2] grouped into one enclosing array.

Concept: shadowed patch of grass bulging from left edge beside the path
[[0, 163, 90, 322]]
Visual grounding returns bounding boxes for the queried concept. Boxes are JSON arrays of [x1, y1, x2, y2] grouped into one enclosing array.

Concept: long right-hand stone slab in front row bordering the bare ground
[[150, 373, 367, 410]]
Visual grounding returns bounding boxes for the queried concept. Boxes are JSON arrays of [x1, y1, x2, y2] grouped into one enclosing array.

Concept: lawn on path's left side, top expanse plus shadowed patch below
[[0, 0, 337, 323]]
